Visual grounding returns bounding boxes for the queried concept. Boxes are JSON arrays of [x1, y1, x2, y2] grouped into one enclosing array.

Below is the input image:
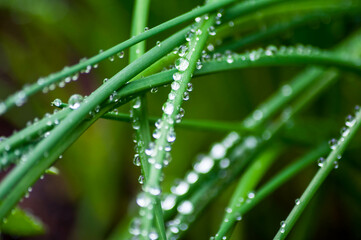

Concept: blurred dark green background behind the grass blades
[[0, 0, 361, 240]]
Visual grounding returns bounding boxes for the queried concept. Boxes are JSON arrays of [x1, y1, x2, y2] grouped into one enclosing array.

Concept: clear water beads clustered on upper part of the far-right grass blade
[[317, 105, 360, 169]]
